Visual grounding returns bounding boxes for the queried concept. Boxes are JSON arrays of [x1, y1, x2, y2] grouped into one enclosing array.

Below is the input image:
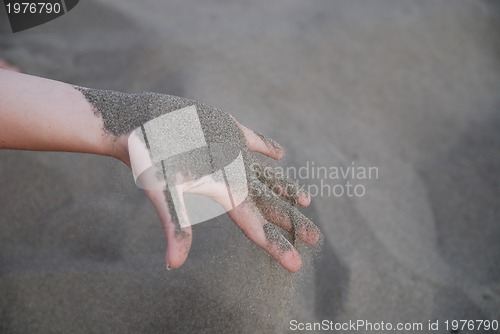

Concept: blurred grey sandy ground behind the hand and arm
[[0, 0, 500, 333]]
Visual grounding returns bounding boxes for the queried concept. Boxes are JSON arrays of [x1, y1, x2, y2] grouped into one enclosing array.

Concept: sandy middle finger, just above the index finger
[[254, 184, 321, 245]]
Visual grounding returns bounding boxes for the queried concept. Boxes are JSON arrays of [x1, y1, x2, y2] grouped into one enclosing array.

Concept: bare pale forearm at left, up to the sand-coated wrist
[[0, 70, 125, 160]]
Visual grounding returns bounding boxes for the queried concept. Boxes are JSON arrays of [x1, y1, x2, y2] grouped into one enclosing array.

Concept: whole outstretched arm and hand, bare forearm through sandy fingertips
[[0, 69, 321, 271]]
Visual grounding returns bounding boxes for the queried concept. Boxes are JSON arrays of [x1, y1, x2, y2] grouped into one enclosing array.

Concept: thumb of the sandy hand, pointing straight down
[[145, 190, 192, 270]]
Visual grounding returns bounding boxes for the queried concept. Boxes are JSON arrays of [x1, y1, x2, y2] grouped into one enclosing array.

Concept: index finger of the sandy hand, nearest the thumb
[[228, 201, 302, 272]]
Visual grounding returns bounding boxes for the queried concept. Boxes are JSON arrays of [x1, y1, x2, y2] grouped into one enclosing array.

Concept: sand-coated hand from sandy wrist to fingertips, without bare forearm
[[77, 88, 321, 272]]
